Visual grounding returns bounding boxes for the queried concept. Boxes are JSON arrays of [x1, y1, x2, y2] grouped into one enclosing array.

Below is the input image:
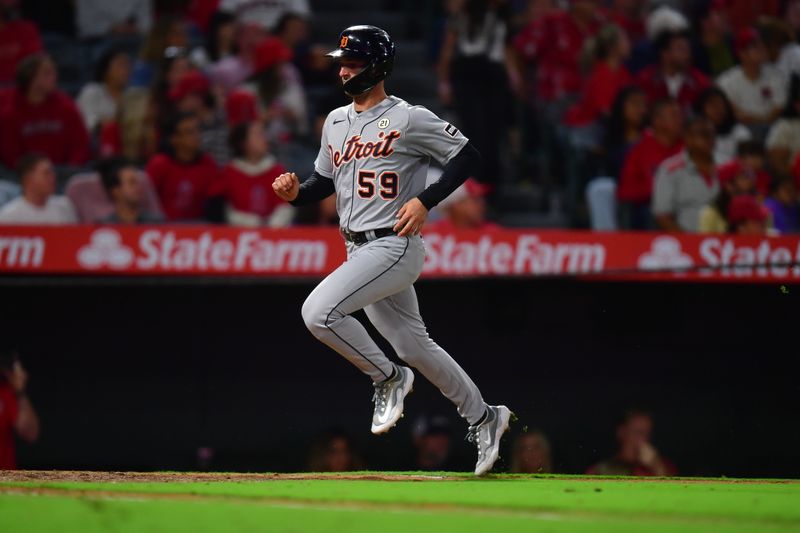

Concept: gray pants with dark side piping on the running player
[[302, 236, 486, 424]]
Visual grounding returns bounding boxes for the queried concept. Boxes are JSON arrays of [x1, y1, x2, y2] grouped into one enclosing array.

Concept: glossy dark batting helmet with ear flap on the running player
[[327, 25, 394, 96]]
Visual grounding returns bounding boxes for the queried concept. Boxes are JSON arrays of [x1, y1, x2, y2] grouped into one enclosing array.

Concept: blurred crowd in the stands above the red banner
[[0, 0, 800, 234]]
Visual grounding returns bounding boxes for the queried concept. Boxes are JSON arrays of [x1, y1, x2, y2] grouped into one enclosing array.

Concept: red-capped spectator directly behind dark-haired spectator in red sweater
[[169, 70, 231, 165]]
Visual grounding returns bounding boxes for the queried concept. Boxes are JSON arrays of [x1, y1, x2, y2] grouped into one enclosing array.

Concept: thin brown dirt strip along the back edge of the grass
[[0, 470, 800, 484]]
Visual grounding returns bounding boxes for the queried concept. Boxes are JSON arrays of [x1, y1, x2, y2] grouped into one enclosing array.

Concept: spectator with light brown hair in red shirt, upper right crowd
[[565, 25, 633, 126]]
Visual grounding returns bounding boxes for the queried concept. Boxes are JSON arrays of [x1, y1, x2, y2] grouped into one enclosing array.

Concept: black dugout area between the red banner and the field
[[0, 278, 800, 477]]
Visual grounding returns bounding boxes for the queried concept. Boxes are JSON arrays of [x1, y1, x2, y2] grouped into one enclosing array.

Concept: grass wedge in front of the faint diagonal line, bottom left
[[0, 489, 796, 533]]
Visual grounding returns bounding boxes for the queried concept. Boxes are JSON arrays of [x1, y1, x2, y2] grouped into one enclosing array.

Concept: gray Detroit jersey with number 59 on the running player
[[314, 96, 467, 231]]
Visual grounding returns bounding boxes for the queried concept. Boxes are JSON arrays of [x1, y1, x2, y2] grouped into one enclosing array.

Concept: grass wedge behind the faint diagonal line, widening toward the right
[[0, 477, 800, 529]]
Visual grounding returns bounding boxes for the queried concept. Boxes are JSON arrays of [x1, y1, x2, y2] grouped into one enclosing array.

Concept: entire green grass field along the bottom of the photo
[[0, 472, 800, 533]]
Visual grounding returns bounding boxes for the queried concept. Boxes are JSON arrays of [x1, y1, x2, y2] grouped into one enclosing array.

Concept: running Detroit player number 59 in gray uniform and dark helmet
[[273, 26, 513, 475]]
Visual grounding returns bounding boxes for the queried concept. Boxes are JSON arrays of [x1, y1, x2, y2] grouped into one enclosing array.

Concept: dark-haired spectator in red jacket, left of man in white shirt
[[637, 32, 711, 111]]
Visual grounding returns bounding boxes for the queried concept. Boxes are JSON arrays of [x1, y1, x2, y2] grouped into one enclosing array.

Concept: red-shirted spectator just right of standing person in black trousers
[[514, 0, 603, 102]]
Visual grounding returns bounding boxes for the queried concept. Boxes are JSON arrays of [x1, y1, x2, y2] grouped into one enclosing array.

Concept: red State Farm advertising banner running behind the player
[[0, 226, 800, 282]]
